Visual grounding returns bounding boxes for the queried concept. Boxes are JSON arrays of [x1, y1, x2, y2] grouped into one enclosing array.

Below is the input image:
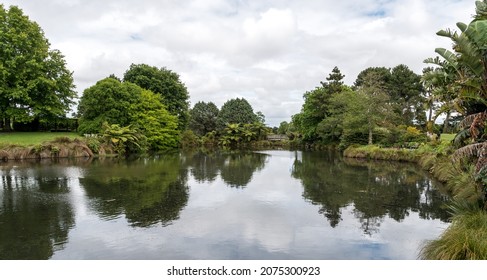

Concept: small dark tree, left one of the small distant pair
[[189, 101, 220, 136]]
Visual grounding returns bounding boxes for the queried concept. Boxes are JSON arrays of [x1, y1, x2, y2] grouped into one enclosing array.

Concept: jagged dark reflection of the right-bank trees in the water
[[292, 152, 449, 232]]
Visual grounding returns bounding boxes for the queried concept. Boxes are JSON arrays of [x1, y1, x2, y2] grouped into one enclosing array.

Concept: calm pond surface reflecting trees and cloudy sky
[[0, 151, 448, 260]]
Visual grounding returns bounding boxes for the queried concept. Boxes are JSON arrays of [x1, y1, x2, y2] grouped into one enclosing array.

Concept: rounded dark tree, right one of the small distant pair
[[217, 98, 259, 130]]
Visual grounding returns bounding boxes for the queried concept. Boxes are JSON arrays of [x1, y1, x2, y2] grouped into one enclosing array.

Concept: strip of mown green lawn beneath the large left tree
[[0, 132, 81, 146]]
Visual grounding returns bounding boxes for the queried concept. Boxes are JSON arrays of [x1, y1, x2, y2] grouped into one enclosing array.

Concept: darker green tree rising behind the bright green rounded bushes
[[123, 64, 189, 130]]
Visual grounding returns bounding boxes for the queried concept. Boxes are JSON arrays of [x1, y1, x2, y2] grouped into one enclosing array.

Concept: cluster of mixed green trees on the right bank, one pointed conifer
[[290, 64, 426, 148]]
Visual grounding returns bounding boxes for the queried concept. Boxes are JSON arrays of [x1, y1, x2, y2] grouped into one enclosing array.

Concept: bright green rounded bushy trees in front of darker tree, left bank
[[78, 78, 179, 150]]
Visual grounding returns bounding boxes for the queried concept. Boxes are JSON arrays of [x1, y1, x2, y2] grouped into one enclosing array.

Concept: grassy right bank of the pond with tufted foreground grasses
[[343, 141, 487, 260]]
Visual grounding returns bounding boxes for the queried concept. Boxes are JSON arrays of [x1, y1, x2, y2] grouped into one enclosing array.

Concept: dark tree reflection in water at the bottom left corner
[[0, 164, 74, 260]]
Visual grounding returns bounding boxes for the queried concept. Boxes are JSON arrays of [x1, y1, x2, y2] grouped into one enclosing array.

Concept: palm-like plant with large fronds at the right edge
[[424, 0, 487, 201]]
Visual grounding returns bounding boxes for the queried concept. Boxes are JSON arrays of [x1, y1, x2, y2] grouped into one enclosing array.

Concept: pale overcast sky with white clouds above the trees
[[0, 0, 475, 126]]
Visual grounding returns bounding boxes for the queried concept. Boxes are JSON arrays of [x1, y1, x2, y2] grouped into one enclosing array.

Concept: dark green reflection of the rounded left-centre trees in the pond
[[79, 154, 188, 227]]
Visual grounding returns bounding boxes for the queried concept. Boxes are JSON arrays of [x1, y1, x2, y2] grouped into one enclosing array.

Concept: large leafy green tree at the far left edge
[[0, 5, 76, 130]]
